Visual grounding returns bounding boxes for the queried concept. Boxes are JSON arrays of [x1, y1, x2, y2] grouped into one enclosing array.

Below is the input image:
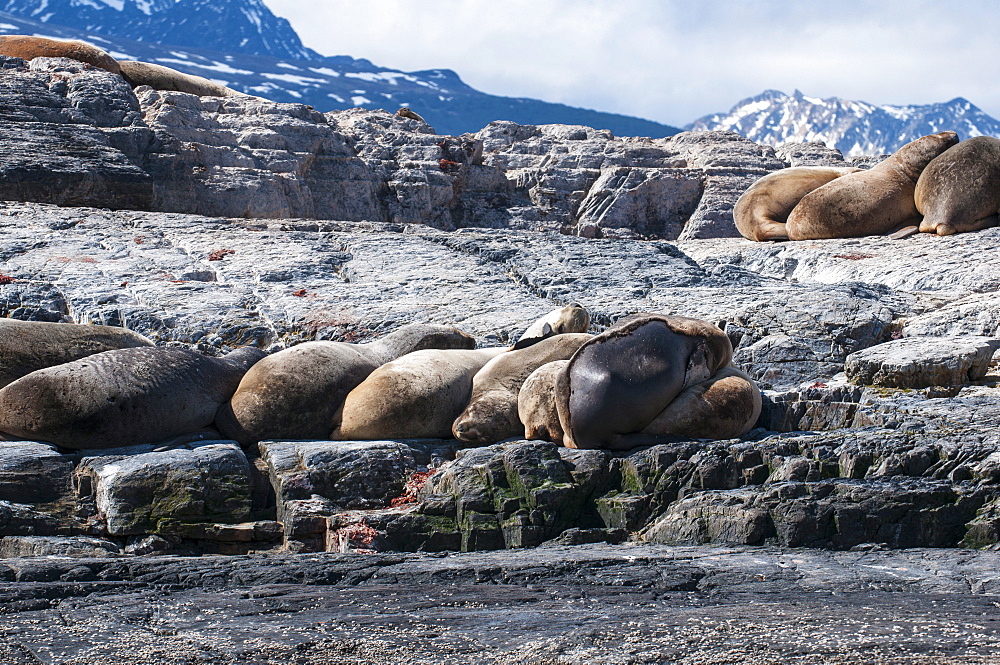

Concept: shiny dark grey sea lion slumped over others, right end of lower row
[[556, 314, 733, 450]]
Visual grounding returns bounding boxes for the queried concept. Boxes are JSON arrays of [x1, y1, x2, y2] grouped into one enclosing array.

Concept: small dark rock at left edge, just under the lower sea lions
[[0, 441, 73, 503]]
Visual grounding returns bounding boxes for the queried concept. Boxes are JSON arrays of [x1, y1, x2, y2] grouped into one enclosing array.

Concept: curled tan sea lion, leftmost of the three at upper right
[[733, 166, 861, 242]]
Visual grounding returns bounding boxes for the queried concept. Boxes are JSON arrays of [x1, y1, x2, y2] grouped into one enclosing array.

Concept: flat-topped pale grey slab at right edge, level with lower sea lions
[[844, 336, 1000, 388]]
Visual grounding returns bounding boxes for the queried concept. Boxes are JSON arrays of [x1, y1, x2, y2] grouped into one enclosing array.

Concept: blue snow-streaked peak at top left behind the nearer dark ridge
[[0, 0, 312, 59]]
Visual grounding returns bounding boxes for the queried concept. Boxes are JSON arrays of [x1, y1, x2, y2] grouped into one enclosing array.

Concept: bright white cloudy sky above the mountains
[[264, 0, 1000, 125]]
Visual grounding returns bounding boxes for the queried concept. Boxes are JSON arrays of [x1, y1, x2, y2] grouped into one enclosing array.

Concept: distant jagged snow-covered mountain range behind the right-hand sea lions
[[685, 90, 1000, 157]]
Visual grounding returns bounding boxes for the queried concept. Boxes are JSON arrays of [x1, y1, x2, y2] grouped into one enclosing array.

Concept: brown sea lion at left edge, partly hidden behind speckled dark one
[[0, 319, 153, 388]]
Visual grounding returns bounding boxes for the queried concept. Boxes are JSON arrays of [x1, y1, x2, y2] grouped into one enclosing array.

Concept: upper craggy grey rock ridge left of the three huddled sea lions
[[0, 58, 842, 240]]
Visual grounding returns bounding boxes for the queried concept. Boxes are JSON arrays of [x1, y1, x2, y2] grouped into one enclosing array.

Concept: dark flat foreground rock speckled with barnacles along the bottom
[[0, 546, 1000, 665]]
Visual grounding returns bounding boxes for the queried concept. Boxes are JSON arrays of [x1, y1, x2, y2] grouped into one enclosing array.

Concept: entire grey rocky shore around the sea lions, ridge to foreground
[[0, 50, 1000, 665]]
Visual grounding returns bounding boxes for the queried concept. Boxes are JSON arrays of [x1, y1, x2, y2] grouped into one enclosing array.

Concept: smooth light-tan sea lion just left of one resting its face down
[[330, 347, 508, 441]]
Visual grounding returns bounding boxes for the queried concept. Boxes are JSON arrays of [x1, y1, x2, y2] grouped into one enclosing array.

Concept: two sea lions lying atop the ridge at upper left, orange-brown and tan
[[0, 35, 249, 97]]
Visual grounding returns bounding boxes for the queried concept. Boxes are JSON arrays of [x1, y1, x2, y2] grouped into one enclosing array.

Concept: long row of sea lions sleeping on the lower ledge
[[0, 304, 761, 450]]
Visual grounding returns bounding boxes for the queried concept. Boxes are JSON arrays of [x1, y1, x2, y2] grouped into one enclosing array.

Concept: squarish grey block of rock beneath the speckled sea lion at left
[[75, 442, 251, 536]]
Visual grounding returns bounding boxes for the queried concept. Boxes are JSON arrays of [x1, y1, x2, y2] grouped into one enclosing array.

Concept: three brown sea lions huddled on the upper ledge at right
[[733, 132, 1000, 241]]
